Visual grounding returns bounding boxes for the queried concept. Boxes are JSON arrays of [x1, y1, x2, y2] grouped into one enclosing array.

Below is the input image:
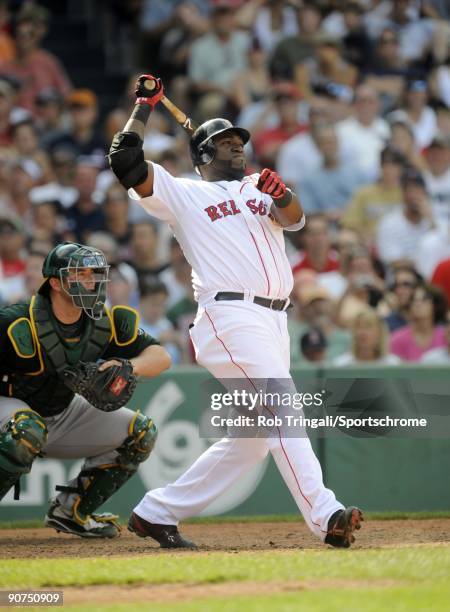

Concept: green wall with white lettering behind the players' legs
[[0, 366, 450, 521]]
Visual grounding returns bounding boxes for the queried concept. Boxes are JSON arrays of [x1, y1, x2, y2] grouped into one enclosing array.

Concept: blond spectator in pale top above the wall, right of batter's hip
[[288, 284, 350, 365]]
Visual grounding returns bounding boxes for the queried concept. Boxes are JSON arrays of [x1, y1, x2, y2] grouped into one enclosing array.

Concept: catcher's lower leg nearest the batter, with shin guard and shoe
[[46, 412, 157, 538]]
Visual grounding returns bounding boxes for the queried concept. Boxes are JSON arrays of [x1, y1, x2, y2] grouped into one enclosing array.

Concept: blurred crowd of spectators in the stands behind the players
[[0, 0, 450, 367]]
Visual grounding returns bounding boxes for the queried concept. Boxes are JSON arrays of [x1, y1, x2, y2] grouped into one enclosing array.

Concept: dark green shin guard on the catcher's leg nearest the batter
[[57, 412, 157, 523]]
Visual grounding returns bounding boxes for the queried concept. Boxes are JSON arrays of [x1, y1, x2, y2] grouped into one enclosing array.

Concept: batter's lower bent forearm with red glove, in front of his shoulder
[[256, 168, 304, 227]]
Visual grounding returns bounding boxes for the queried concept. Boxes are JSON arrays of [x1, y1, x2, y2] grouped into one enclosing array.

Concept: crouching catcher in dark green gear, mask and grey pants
[[0, 243, 170, 538]]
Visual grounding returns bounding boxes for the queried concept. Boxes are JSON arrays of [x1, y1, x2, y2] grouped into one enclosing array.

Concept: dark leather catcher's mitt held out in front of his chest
[[63, 357, 136, 412]]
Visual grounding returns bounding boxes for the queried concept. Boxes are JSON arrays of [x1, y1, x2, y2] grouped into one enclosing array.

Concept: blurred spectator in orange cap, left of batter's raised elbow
[[48, 89, 106, 161]]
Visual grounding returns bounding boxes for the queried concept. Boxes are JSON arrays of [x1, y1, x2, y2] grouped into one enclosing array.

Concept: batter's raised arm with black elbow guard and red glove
[[108, 74, 164, 197]]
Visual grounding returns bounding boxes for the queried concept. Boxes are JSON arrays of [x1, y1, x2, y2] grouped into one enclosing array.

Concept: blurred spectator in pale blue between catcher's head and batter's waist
[[139, 282, 181, 365]]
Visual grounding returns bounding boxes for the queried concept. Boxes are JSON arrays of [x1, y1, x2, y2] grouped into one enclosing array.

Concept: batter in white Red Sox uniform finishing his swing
[[109, 75, 362, 548]]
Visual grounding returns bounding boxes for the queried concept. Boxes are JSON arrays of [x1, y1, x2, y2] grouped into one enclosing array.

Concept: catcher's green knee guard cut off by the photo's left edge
[[0, 408, 48, 499]]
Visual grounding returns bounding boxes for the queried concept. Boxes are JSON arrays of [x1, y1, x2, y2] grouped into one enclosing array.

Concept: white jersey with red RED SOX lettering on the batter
[[130, 164, 305, 300]]
